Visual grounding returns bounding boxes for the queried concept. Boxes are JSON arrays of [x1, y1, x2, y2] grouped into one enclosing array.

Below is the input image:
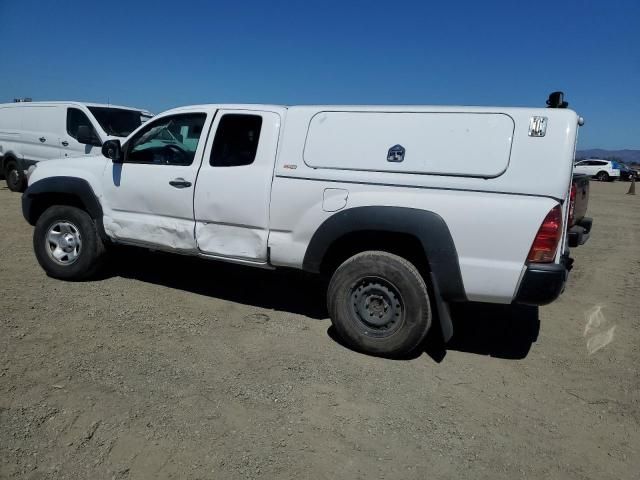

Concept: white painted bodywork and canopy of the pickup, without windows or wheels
[[30, 105, 578, 303]]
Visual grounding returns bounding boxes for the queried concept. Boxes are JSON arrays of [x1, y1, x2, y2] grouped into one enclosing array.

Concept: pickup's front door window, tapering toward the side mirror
[[125, 113, 207, 165]]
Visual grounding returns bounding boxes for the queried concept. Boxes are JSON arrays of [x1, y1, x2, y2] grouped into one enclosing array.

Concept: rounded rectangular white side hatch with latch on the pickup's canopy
[[304, 111, 514, 177]]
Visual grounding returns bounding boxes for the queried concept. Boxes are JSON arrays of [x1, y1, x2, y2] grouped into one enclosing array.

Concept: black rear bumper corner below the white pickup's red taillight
[[513, 257, 573, 305]]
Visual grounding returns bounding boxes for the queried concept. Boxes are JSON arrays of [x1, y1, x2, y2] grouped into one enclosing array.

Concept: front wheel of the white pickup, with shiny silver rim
[[33, 205, 105, 280]]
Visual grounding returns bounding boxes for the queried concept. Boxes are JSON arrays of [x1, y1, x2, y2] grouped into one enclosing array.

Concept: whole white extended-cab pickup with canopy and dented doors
[[22, 96, 582, 356]]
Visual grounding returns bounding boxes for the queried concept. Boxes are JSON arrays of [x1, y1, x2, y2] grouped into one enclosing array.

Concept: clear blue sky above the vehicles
[[0, 0, 640, 148]]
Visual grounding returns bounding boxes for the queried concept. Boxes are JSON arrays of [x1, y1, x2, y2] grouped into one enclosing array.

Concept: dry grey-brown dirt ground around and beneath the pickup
[[0, 182, 640, 480]]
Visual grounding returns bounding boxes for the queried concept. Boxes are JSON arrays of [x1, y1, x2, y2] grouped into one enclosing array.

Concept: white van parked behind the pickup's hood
[[0, 102, 152, 191]]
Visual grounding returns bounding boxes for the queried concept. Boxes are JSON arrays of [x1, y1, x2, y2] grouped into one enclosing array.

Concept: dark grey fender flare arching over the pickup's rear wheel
[[303, 206, 466, 301]]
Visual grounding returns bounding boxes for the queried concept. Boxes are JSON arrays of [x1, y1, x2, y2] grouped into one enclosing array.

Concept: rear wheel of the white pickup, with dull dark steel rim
[[327, 251, 432, 357]]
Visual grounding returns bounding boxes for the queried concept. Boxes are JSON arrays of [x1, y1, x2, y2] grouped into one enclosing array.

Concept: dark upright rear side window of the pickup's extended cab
[[209, 113, 262, 167]]
